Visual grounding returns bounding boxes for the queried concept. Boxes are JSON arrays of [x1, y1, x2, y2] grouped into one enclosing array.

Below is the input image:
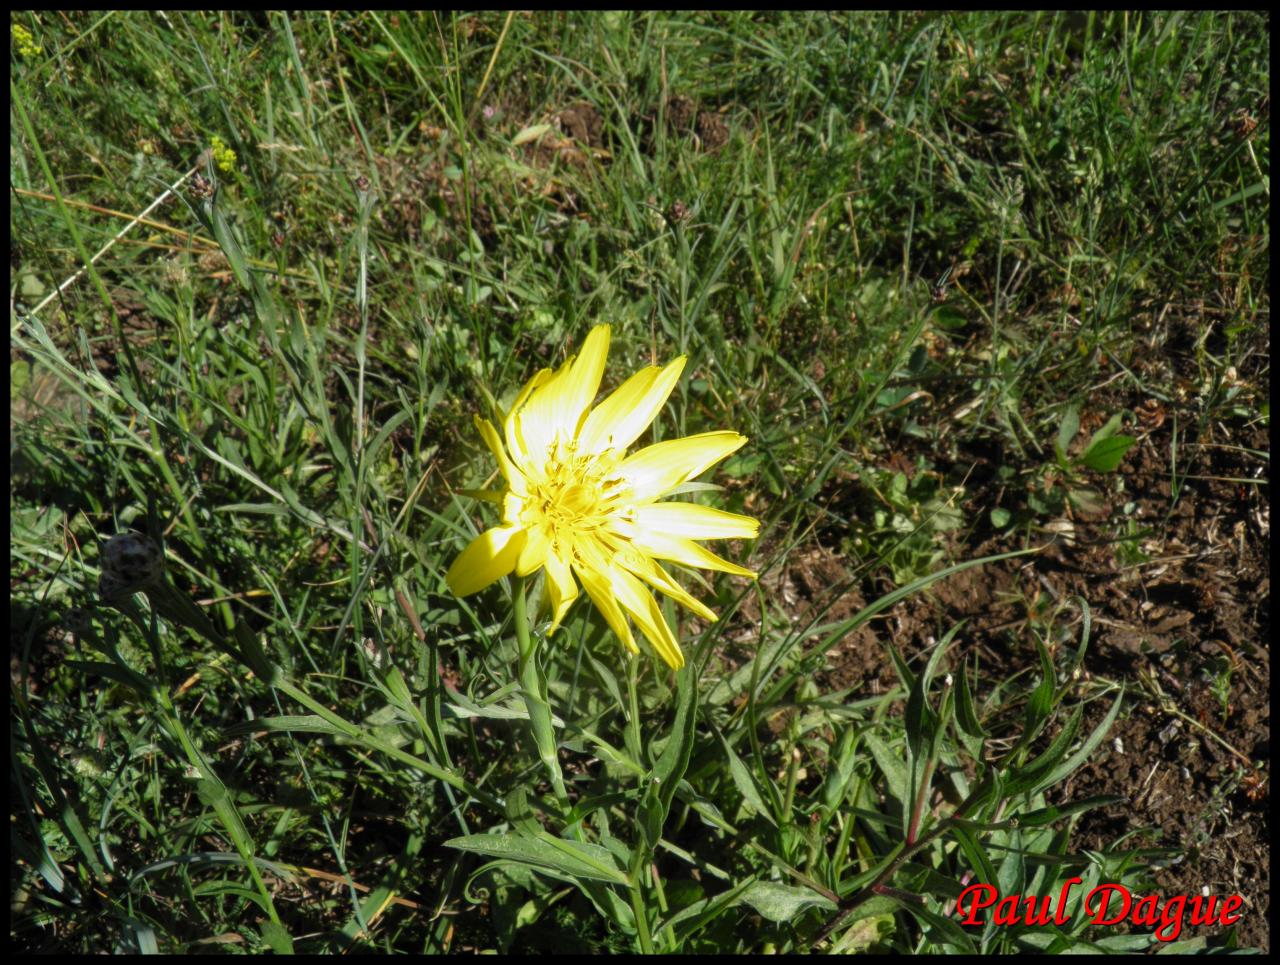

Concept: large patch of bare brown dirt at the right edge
[[803, 355, 1271, 950]]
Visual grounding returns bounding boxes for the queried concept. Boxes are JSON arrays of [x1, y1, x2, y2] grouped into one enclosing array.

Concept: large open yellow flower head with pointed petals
[[445, 325, 760, 668]]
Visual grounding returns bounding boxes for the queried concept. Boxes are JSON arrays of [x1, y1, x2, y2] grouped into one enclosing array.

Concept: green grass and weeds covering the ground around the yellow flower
[[10, 12, 1270, 952]]
